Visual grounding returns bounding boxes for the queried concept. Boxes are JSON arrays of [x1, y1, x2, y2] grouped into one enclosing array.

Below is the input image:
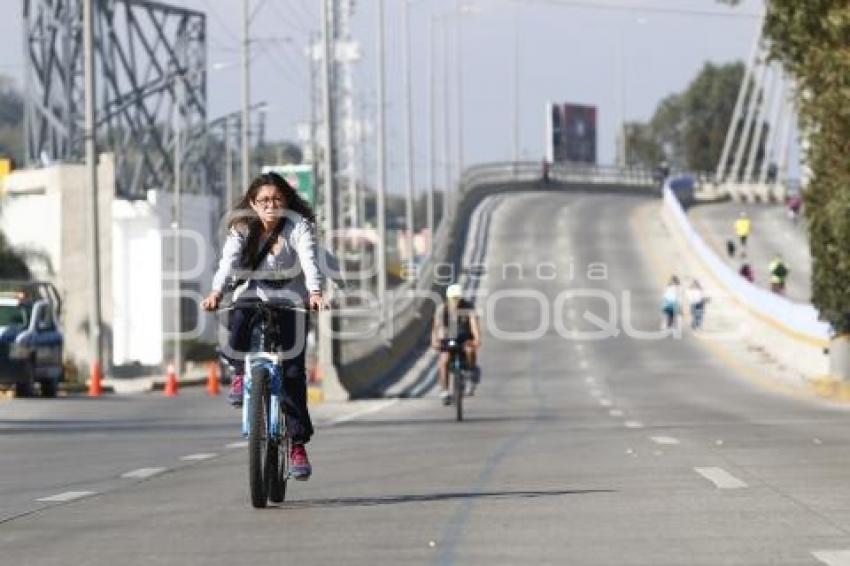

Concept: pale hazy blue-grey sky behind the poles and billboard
[[0, 0, 762, 191]]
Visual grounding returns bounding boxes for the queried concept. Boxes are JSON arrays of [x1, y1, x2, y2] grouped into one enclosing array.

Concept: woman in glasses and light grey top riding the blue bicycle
[[201, 173, 325, 480]]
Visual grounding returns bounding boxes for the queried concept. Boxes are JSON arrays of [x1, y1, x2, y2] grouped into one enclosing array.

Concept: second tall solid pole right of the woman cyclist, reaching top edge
[[375, 0, 387, 312]]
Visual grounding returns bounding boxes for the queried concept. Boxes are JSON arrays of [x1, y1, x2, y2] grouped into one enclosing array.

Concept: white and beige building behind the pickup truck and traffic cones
[[0, 155, 220, 372]]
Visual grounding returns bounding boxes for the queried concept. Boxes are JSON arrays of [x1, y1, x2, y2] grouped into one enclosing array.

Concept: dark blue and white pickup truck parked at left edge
[[0, 280, 64, 397]]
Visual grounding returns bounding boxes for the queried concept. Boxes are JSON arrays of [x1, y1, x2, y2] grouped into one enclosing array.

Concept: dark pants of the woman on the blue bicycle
[[228, 309, 313, 443]]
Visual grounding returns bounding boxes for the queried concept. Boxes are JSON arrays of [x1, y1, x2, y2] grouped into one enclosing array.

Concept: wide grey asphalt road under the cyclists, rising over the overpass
[[0, 193, 850, 566]]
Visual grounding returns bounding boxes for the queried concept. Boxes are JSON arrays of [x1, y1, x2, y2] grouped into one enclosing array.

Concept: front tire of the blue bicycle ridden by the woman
[[248, 369, 270, 509]]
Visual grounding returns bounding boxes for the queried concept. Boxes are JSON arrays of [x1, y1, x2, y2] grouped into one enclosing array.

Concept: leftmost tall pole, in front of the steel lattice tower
[[83, 0, 101, 377]]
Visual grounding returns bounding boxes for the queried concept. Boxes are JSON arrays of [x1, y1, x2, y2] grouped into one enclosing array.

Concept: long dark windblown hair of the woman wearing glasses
[[228, 173, 316, 269]]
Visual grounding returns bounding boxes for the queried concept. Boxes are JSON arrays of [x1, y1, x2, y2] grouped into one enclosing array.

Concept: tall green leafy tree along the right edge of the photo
[[764, 0, 850, 335]]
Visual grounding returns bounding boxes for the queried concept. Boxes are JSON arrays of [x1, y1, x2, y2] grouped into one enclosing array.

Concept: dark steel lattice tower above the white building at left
[[24, 0, 210, 198]]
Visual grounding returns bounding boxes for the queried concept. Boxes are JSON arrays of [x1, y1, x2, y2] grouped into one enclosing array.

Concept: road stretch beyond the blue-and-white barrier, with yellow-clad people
[[688, 202, 812, 303]]
